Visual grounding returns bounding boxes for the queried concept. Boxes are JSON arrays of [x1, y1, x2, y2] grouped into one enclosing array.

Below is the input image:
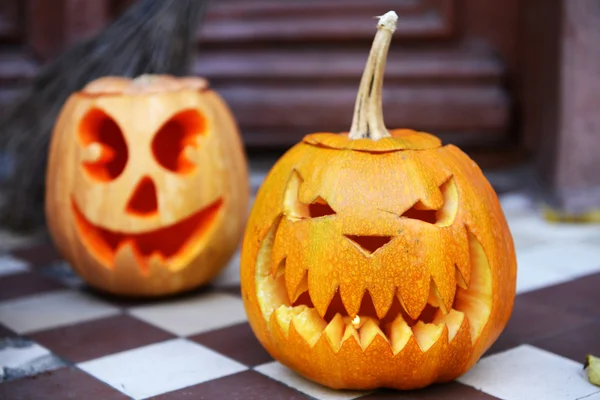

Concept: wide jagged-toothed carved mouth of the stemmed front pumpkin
[[255, 220, 492, 354]]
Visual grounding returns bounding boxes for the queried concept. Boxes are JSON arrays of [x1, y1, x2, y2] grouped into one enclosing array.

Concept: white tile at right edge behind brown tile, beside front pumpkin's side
[[517, 242, 600, 293]]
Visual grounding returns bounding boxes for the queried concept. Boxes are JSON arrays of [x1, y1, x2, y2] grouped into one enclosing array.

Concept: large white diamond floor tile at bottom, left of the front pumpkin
[[78, 339, 247, 399]]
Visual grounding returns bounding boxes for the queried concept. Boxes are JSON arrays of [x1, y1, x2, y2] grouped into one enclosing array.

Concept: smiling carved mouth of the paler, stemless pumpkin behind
[[71, 198, 223, 270]]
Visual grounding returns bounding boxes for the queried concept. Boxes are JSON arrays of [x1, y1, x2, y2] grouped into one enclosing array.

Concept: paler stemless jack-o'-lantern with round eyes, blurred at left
[[45, 75, 249, 296]]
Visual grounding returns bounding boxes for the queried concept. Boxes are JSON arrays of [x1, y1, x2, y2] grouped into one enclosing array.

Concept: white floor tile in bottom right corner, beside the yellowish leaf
[[458, 345, 599, 400]]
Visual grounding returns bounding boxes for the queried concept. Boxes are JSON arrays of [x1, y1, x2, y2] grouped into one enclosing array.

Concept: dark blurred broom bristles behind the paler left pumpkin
[[0, 0, 208, 231]]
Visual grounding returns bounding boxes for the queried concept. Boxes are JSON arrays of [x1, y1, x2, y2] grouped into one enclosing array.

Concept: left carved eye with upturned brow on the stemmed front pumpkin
[[283, 170, 336, 219]]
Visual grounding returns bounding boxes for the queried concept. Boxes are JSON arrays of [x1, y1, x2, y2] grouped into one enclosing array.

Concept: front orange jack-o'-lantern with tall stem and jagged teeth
[[241, 12, 516, 389]]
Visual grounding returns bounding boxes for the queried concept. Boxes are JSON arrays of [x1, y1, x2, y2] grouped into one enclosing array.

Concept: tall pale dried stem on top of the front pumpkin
[[348, 11, 398, 140]]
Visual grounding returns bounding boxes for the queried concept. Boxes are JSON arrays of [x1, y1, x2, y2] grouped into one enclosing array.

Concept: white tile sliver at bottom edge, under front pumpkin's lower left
[[254, 361, 368, 400]]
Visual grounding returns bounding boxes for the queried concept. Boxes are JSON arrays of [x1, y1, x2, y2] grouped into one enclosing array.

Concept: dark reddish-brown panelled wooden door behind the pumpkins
[[0, 0, 522, 164]]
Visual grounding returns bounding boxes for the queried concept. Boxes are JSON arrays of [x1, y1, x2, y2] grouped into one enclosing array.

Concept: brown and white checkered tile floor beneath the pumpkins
[[0, 195, 600, 400]]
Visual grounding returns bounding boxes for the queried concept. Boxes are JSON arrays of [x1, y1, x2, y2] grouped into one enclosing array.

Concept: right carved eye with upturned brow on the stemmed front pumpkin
[[382, 175, 458, 226]]
